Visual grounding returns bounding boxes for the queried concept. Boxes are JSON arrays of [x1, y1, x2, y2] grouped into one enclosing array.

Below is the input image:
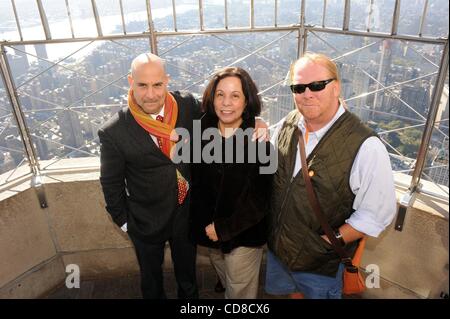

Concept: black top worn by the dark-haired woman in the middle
[[190, 114, 272, 253]]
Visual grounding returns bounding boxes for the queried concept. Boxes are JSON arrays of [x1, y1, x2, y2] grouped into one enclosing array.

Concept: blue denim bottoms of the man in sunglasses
[[265, 250, 344, 299]]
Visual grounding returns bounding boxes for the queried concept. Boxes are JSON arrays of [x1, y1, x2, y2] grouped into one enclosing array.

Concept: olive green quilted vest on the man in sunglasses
[[268, 110, 376, 276]]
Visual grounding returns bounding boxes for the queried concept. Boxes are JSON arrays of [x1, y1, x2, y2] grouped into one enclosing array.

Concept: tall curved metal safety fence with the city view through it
[[0, 0, 449, 205]]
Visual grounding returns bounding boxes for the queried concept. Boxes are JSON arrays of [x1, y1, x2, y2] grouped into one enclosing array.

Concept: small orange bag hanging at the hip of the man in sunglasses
[[342, 237, 366, 295]]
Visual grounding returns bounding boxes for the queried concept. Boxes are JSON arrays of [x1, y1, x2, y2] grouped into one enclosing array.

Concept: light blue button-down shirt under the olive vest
[[271, 105, 397, 237]]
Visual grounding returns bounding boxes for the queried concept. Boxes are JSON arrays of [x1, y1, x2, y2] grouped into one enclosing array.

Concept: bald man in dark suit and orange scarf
[[98, 54, 200, 299]]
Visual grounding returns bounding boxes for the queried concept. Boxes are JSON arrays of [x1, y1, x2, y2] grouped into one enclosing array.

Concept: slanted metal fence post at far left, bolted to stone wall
[[0, 45, 47, 208]]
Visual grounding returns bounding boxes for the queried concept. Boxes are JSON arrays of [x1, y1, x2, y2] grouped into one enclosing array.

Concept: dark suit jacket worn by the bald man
[[98, 92, 200, 242]]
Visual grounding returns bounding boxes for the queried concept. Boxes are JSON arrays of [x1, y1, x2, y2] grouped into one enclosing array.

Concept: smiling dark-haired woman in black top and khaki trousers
[[191, 67, 272, 299]]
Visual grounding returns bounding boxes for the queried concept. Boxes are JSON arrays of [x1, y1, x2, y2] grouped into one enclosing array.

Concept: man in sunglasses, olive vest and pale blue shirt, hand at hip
[[266, 53, 396, 299]]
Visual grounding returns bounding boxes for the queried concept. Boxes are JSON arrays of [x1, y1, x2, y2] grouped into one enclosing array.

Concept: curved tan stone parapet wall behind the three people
[[0, 180, 449, 298]]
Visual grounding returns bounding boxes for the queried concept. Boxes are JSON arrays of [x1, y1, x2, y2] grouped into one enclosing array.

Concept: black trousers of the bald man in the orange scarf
[[129, 232, 198, 299]]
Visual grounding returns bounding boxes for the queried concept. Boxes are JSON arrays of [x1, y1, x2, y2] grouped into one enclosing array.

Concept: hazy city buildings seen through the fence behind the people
[[0, 0, 448, 190]]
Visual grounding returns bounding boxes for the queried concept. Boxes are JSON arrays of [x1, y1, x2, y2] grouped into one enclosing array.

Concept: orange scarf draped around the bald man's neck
[[128, 89, 178, 158]]
